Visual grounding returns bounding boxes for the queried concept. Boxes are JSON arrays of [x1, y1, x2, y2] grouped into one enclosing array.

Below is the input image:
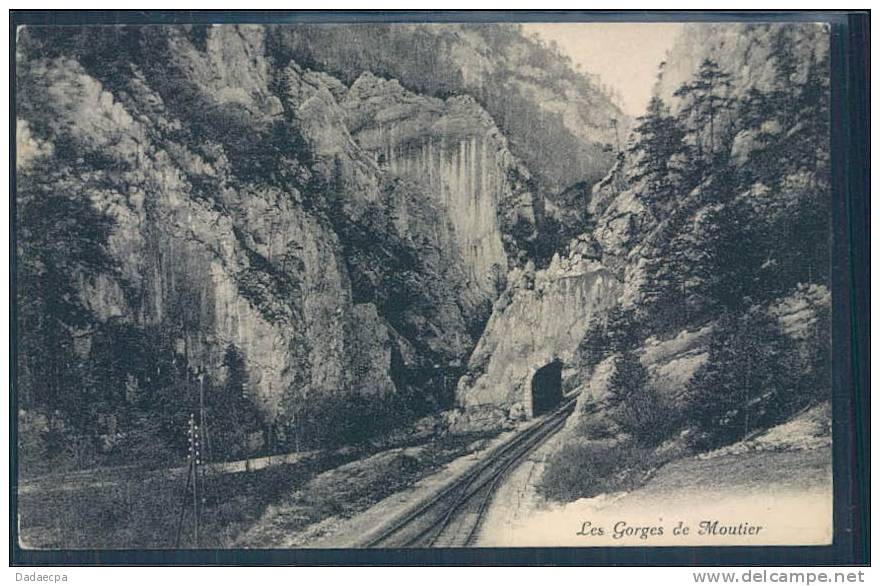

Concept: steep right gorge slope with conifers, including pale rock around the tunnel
[[458, 24, 830, 456]]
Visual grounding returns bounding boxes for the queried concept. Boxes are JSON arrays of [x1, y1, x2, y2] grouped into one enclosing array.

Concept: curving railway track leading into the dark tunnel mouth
[[363, 397, 576, 548]]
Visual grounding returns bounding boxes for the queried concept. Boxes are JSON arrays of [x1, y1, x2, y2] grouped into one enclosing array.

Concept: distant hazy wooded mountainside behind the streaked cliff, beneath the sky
[[273, 23, 632, 248]]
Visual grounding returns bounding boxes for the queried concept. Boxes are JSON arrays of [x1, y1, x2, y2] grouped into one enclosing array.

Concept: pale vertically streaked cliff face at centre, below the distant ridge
[[343, 73, 535, 299]]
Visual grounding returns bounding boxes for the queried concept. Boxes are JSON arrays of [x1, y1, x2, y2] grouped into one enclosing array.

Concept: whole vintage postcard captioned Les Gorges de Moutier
[[14, 23, 832, 549]]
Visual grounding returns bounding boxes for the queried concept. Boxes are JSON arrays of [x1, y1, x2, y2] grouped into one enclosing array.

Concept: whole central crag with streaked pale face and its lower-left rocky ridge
[[284, 63, 535, 361]]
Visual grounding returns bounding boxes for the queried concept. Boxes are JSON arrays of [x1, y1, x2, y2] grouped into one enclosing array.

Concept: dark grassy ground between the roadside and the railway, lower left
[[19, 428, 496, 549]]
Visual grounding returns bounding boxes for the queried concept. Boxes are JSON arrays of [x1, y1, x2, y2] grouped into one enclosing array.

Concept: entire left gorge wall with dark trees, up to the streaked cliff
[[16, 26, 616, 460]]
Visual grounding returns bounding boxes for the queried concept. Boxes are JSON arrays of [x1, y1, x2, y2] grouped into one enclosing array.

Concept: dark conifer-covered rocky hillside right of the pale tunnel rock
[[546, 25, 831, 495]]
